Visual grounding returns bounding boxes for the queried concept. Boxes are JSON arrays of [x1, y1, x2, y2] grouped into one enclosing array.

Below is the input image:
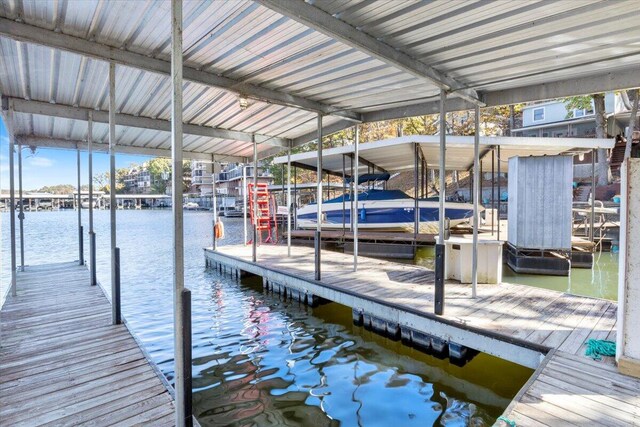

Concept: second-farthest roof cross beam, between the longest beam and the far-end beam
[[10, 98, 289, 147]]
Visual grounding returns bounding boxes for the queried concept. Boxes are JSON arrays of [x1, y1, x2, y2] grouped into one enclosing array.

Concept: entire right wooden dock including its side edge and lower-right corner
[[205, 245, 640, 426]]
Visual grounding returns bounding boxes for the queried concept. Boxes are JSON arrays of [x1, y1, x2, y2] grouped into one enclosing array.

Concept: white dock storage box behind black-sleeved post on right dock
[[436, 237, 503, 284]]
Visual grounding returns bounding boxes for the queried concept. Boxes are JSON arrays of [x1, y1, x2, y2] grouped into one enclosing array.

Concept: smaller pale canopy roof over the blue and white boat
[[273, 135, 615, 176]]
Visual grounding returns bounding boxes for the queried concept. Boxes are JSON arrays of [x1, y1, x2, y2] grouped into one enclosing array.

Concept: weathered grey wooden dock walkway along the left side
[[0, 263, 175, 426]]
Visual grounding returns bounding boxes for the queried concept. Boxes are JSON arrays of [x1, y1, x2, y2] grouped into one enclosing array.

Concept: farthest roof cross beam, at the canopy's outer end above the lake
[[16, 135, 246, 163]]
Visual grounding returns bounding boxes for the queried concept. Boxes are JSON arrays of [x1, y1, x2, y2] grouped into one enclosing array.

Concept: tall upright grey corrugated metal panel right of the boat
[[507, 156, 573, 250]]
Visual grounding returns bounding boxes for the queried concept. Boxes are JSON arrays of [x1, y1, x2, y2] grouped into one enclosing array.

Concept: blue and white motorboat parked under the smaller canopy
[[297, 189, 473, 233]]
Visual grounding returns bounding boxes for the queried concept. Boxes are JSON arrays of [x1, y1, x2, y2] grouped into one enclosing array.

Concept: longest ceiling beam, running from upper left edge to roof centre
[[0, 18, 360, 122]]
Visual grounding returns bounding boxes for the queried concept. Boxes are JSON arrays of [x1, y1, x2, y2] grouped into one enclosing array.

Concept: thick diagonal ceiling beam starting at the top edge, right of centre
[[255, 0, 484, 105]]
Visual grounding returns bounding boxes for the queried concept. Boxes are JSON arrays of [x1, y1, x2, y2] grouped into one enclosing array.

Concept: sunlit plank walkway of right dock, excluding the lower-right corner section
[[218, 245, 617, 363]]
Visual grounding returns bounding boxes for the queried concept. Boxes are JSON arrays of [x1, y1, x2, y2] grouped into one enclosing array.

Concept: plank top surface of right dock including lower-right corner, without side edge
[[209, 245, 640, 426]]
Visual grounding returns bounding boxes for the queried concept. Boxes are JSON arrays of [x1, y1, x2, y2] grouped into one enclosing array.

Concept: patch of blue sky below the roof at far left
[[0, 116, 151, 191]]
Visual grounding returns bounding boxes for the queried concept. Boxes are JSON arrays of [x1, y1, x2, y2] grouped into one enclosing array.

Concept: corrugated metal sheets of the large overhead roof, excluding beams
[[0, 0, 640, 160]]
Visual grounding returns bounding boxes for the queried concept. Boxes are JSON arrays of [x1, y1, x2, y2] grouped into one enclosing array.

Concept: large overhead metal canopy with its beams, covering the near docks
[[0, 0, 640, 161]]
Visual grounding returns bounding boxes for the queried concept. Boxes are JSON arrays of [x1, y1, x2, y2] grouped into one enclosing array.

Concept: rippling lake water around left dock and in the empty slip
[[1, 211, 532, 426]]
